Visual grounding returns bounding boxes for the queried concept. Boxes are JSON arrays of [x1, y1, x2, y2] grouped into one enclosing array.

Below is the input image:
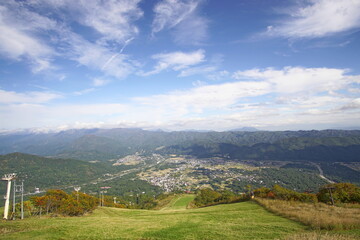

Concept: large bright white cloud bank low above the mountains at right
[[131, 67, 360, 130]]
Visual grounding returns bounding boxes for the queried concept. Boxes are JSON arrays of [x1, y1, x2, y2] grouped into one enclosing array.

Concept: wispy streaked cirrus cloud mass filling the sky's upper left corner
[[0, 0, 143, 78]]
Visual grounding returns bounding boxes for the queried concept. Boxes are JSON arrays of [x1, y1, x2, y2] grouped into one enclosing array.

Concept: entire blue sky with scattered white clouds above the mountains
[[0, 0, 360, 131]]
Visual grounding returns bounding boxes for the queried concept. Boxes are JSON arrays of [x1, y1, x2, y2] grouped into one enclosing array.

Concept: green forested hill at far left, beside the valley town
[[0, 153, 118, 191]]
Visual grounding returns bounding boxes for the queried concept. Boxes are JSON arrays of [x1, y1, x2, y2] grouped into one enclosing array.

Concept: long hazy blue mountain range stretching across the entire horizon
[[0, 128, 360, 161]]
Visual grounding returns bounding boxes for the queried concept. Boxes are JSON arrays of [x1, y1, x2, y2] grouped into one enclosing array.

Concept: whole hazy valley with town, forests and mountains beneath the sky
[[0, 129, 360, 200]]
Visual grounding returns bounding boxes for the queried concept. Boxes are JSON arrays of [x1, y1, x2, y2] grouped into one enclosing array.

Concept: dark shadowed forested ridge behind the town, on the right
[[159, 137, 360, 162]]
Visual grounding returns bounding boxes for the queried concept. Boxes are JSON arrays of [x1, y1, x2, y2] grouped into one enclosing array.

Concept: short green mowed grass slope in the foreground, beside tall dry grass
[[0, 202, 305, 239]]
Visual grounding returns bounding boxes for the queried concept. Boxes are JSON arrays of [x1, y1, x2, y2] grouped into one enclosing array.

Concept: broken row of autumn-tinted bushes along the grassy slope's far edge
[[12, 183, 360, 216]]
